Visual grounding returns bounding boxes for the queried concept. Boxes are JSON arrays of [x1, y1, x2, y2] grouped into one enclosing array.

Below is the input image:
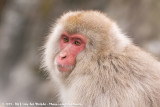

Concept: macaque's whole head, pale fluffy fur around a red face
[[44, 11, 129, 81]]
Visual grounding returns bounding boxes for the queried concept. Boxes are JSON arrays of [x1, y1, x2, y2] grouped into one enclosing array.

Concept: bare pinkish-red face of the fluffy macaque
[[56, 32, 86, 72]]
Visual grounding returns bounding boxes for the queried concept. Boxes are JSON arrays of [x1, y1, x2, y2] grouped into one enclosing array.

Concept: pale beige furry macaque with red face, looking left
[[43, 11, 160, 107]]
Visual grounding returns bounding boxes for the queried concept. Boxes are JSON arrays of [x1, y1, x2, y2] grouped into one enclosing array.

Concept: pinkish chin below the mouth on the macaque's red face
[[57, 65, 73, 72]]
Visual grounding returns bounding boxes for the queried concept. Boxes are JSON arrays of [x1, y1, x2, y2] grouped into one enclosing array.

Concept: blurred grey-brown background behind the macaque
[[0, 0, 160, 107]]
